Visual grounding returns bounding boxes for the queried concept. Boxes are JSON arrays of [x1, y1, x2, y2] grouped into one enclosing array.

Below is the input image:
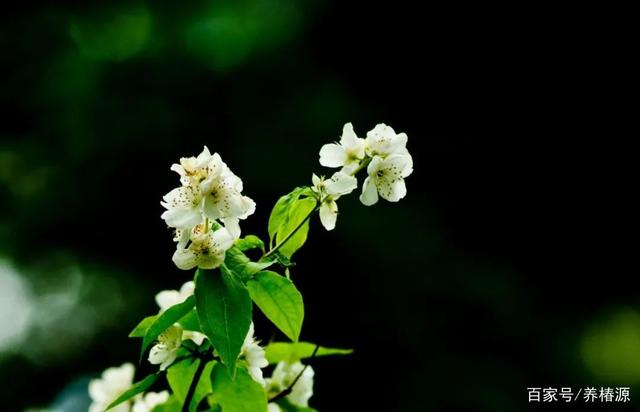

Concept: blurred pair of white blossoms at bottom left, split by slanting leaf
[[89, 363, 169, 412]]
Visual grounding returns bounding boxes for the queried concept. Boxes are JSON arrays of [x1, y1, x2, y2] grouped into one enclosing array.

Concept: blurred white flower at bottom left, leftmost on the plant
[[89, 363, 135, 412]]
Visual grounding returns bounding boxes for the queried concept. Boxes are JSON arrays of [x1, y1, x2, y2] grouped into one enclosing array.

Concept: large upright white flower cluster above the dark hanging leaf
[[160, 146, 256, 270]]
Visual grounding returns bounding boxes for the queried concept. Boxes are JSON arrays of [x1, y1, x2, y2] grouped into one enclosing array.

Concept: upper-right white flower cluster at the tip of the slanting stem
[[312, 123, 413, 230]]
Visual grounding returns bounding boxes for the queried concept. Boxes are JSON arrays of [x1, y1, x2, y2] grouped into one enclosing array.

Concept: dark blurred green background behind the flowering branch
[[0, 0, 640, 411]]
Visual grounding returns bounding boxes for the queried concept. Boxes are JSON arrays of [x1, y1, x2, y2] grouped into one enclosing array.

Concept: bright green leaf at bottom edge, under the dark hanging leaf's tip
[[211, 364, 267, 412]]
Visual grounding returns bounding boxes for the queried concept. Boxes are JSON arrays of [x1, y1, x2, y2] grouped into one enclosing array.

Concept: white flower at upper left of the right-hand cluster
[[320, 123, 365, 173]]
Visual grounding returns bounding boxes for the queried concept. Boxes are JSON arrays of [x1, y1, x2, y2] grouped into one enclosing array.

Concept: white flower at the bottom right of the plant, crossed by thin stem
[[267, 362, 314, 408]]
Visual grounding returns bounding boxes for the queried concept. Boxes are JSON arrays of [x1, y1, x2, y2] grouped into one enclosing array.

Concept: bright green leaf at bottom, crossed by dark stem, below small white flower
[[167, 359, 216, 411]]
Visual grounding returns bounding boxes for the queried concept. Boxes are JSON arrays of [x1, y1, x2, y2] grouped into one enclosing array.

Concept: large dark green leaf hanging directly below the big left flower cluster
[[195, 266, 252, 375]]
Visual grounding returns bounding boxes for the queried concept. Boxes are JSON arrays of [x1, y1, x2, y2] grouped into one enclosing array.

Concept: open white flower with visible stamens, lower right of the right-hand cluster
[[360, 154, 413, 206]]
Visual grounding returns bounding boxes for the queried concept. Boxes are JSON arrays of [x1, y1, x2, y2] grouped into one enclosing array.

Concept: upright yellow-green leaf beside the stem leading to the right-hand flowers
[[276, 197, 317, 258]]
